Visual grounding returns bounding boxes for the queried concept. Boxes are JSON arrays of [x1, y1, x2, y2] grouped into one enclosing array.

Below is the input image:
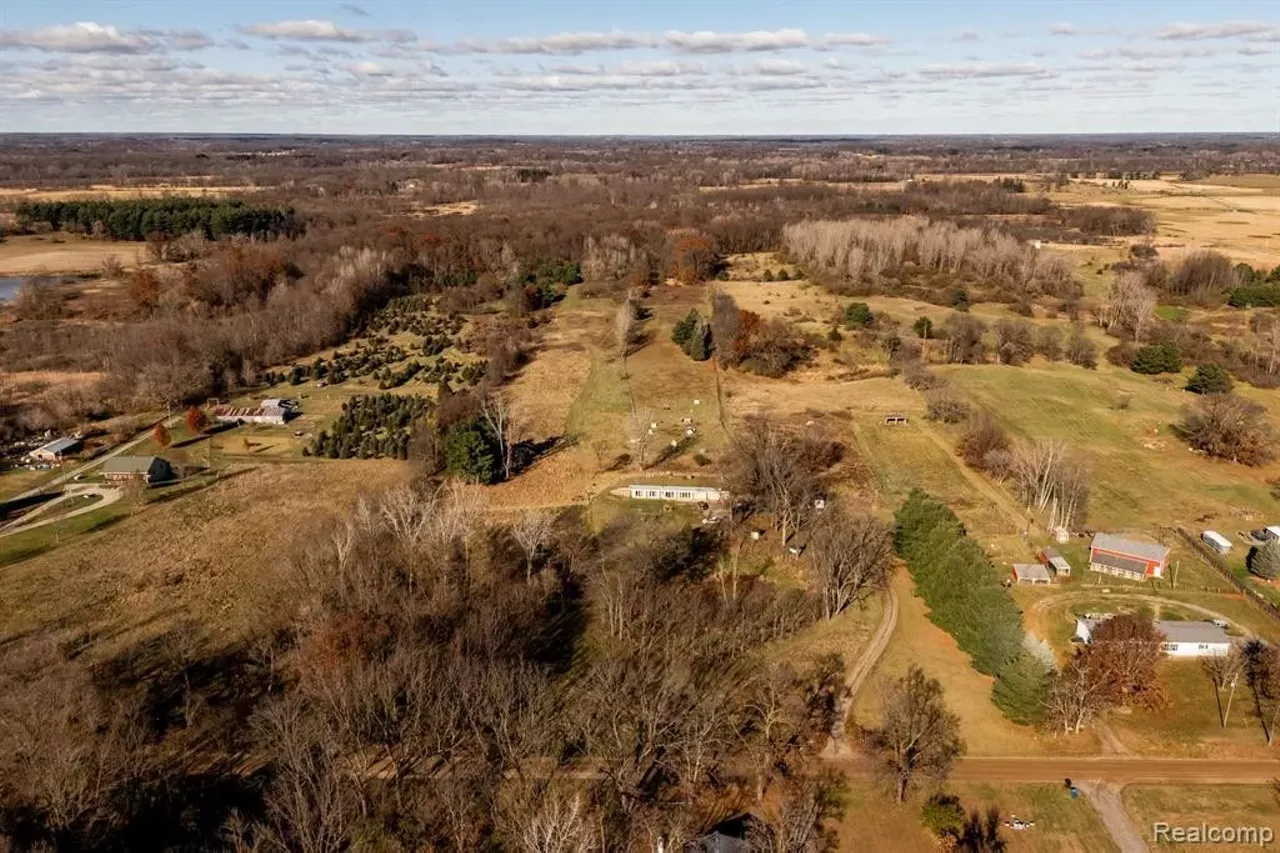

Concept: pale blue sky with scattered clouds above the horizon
[[0, 0, 1280, 136]]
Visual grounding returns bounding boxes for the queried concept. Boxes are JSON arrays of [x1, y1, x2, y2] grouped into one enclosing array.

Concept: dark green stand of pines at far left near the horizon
[[17, 197, 302, 240]]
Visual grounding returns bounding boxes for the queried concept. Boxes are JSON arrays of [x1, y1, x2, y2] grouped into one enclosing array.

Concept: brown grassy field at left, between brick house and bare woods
[[0, 460, 407, 660]]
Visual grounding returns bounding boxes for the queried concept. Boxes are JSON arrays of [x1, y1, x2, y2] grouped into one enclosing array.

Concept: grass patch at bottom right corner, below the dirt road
[[1121, 785, 1280, 853]]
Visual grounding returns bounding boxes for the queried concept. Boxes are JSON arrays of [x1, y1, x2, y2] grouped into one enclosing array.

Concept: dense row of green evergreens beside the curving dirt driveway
[[893, 489, 1047, 722]]
